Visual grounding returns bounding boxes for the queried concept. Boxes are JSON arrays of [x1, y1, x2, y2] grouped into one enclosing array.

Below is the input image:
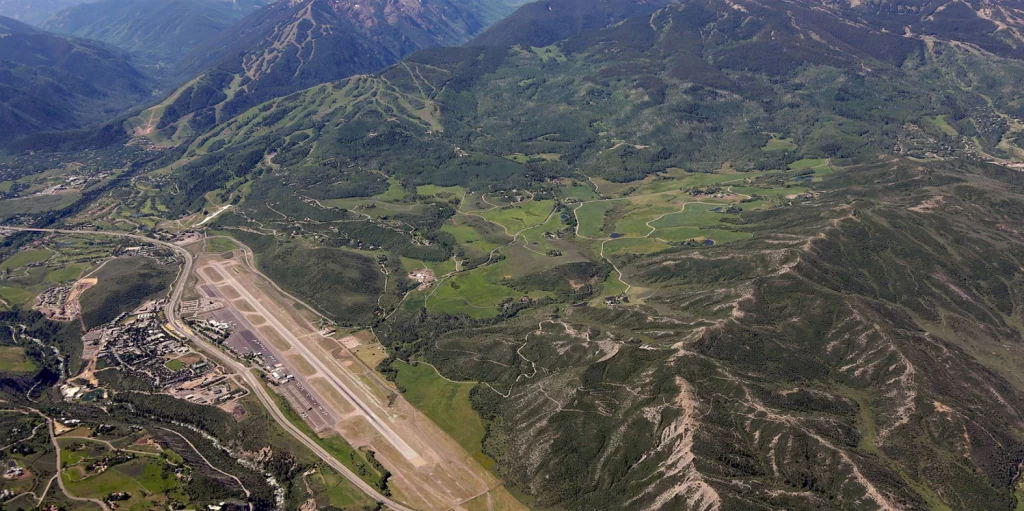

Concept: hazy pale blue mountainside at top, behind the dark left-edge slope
[[42, 0, 270, 74]]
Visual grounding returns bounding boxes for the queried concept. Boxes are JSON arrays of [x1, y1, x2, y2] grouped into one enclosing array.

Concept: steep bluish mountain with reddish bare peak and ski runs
[[128, 0, 513, 146]]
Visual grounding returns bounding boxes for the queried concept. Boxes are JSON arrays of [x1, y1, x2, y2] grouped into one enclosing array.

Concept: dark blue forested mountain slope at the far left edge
[[0, 16, 154, 140]]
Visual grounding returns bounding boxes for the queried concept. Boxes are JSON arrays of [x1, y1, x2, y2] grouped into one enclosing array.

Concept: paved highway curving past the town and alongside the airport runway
[[0, 226, 415, 511]]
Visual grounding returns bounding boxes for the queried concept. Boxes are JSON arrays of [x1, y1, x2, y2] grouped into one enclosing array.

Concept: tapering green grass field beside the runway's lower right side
[[394, 360, 495, 470]]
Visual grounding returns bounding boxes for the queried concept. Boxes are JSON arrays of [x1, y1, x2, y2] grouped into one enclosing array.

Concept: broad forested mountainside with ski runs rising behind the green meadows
[[140, 0, 1024, 208]]
